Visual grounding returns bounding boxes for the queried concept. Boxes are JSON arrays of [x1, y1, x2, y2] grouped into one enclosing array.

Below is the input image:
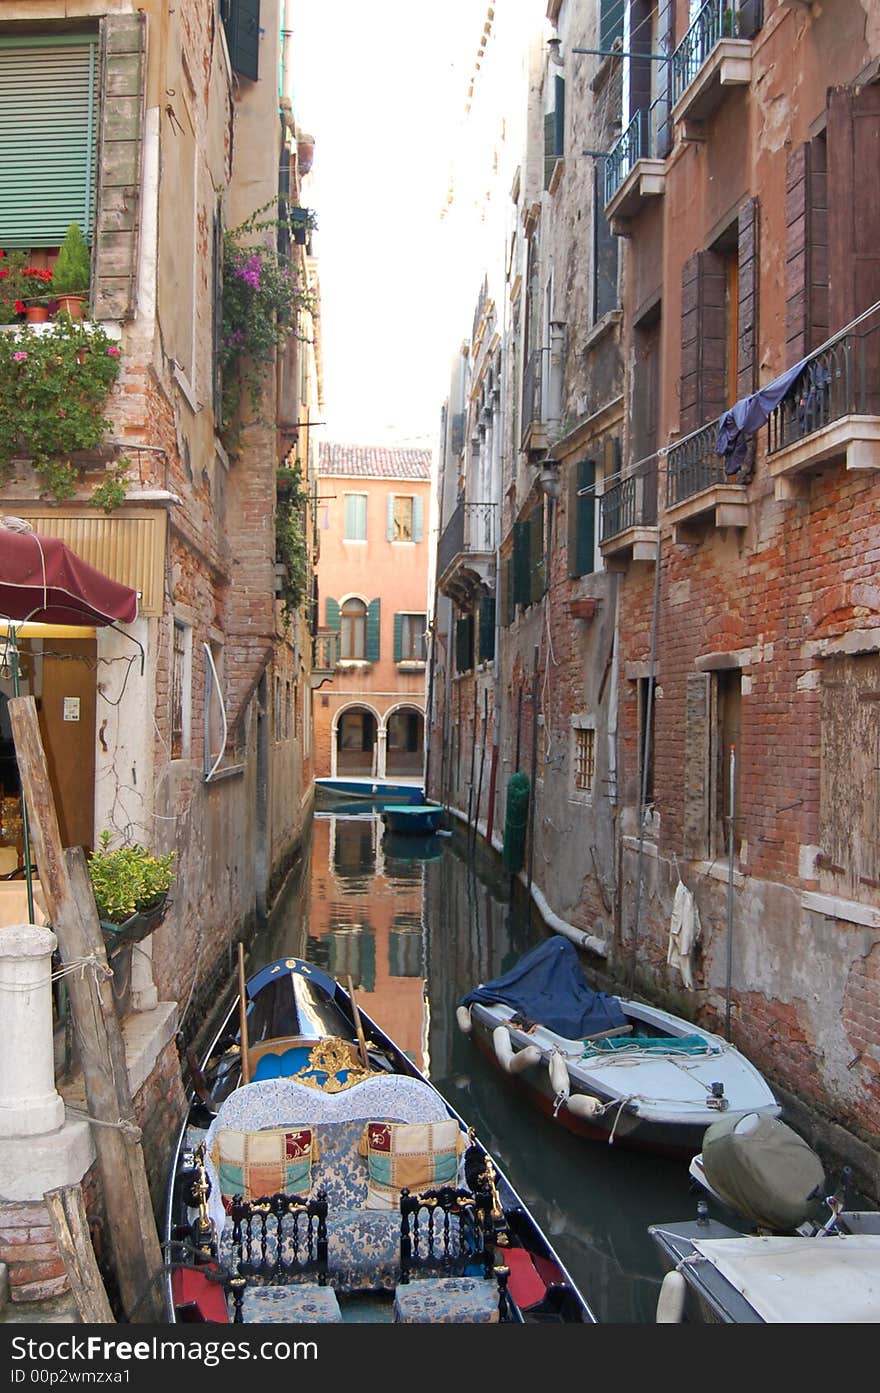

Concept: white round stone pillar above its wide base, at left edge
[[0, 924, 64, 1137]]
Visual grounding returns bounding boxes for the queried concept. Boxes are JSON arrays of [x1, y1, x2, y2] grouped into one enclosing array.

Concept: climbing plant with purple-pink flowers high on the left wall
[[220, 205, 315, 430]]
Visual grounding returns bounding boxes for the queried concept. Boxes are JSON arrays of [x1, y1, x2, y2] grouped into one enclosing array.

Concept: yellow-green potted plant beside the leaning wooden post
[[88, 830, 177, 946]]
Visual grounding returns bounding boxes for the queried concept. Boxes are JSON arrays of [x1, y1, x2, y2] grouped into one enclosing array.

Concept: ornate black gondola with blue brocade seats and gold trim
[[164, 958, 595, 1325]]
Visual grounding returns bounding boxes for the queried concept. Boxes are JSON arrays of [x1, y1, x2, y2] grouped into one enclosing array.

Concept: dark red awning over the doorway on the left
[[0, 524, 138, 625]]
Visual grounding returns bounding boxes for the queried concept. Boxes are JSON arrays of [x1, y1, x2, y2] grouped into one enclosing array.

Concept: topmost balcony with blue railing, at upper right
[[671, 0, 763, 123]]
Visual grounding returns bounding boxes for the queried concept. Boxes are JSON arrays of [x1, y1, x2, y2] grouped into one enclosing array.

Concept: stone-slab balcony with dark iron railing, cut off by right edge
[[767, 315, 880, 499]]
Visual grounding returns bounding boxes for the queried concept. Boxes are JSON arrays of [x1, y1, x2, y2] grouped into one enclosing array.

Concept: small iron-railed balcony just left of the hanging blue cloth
[[666, 421, 749, 542]]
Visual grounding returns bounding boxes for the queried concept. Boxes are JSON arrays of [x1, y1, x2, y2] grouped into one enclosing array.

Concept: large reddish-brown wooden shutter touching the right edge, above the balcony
[[827, 86, 880, 333]]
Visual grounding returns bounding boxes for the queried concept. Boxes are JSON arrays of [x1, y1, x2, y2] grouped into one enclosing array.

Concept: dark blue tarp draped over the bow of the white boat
[[462, 935, 628, 1039]]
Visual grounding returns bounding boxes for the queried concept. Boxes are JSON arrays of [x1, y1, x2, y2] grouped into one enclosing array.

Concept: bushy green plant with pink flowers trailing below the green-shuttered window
[[0, 319, 121, 499]]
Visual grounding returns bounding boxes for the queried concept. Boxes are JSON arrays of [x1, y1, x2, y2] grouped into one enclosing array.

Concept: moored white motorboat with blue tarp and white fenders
[[457, 935, 781, 1156]]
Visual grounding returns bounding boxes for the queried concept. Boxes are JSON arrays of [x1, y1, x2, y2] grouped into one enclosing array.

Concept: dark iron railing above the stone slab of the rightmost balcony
[[767, 316, 880, 454]]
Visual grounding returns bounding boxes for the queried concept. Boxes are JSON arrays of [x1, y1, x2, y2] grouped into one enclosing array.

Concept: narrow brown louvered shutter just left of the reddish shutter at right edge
[[785, 132, 828, 366]]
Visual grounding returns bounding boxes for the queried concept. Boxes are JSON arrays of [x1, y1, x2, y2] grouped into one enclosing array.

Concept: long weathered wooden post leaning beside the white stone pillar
[[8, 697, 164, 1323]]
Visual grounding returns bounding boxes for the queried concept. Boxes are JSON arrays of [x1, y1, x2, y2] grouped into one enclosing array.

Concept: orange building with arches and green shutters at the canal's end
[[315, 443, 432, 779]]
